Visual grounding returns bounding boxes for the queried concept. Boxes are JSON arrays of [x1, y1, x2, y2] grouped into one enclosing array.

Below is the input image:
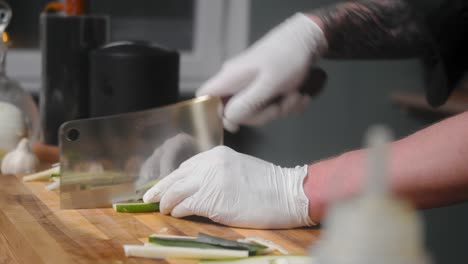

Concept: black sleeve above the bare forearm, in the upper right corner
[[409, 0, 468, 107]]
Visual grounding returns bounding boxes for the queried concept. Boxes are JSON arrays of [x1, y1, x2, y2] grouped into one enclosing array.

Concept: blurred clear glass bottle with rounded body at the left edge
[[0, 1, 40, 158]]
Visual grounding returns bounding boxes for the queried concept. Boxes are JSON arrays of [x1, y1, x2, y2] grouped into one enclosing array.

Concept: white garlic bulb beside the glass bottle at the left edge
[[2, 138, 39, 174]]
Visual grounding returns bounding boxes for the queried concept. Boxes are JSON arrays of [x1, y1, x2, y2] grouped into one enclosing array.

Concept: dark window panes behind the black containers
[[7, 0, 194, 50]]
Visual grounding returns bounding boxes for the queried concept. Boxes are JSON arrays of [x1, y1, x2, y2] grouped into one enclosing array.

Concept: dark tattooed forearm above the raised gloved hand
[[311, 0, 431, 59]]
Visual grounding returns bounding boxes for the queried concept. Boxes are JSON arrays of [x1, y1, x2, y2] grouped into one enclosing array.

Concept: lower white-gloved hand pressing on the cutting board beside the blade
[[143, 146, 314, 229]]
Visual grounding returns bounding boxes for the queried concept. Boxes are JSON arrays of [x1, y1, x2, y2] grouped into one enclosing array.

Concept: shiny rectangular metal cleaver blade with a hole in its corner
[[59, 96, 223, 209]]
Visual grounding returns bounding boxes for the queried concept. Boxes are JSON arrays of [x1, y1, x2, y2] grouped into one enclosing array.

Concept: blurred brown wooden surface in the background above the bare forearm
[[391, 90, 468, 115]]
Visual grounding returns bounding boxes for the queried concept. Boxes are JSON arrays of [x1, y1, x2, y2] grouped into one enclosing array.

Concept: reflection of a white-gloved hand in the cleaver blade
[[136, 133, 199, 186]]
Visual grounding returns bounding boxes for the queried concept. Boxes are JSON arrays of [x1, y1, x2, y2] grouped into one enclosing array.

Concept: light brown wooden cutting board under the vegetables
[[0, 171, 319, 264]]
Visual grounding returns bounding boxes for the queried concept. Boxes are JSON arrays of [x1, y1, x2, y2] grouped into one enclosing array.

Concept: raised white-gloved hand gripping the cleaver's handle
[[197, 13, 327, 132]]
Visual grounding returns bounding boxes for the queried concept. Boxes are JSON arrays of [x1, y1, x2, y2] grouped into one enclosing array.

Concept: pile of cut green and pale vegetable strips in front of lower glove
[[124, 233, 312, 264]]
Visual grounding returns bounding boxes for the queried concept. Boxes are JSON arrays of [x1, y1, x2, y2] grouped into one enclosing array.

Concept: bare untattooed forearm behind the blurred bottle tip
[[304, 112, 468, 222]]
